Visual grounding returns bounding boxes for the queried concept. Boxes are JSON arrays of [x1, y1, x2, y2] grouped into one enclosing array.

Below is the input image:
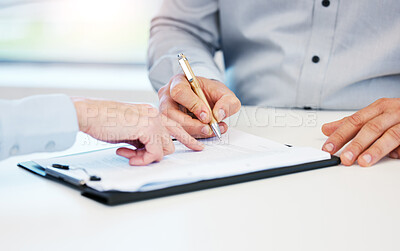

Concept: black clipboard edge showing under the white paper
[[18, 156, 340, 206]]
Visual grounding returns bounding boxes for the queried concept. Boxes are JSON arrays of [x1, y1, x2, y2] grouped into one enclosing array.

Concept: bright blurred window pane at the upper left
[[0, 0, 161, 64]]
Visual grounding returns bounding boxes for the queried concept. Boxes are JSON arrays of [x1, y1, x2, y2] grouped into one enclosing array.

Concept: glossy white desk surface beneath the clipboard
[[0, 107, 400, 251]]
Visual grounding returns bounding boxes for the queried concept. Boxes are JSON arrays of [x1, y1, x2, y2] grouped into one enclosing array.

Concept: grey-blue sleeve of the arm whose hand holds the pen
[[147, 0, 223, 90]]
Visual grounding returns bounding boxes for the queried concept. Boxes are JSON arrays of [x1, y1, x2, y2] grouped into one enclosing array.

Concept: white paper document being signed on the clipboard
[[35, 129, 331, 192]]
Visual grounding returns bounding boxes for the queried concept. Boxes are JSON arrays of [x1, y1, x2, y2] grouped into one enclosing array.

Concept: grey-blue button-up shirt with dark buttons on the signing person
[[148, 0, 400, 109]]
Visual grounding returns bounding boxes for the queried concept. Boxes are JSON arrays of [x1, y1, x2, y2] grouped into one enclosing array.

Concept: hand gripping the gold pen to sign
[[158, 74, 241, 138]]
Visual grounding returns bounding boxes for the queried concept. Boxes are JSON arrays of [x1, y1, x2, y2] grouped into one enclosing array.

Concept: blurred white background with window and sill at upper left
[[0, 0, 162, 102]]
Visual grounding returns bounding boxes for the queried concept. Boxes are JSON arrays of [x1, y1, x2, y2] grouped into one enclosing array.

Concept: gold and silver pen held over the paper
[[178, 53, 221, 139]]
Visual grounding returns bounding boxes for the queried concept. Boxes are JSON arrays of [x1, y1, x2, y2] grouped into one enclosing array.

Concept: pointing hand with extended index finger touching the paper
[[72, 98, 204, 165]]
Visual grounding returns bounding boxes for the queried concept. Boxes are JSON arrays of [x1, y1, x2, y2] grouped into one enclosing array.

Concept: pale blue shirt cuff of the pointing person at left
[[0, 94, 79, 160]]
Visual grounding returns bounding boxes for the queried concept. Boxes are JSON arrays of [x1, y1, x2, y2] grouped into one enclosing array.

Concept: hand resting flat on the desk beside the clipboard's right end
[[322, 98, 400, 167]]
